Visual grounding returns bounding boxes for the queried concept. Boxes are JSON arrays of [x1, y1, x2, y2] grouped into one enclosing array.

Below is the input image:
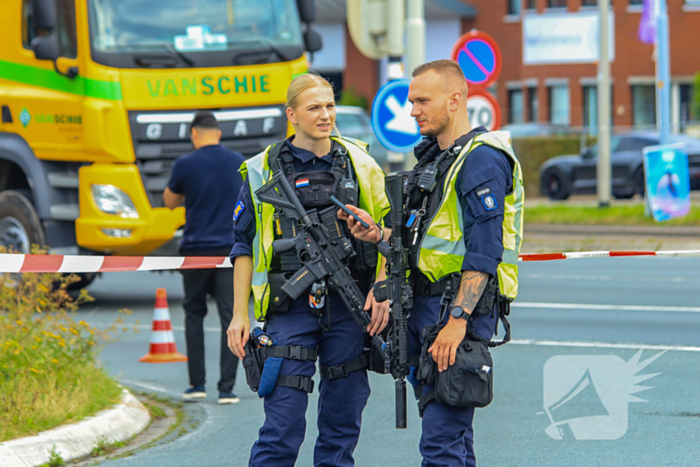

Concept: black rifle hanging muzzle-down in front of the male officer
[[374, 174, 413, 428]]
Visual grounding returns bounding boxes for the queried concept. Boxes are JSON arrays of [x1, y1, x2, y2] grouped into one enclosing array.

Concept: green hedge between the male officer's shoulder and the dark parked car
[[513, 136, 592, 196]]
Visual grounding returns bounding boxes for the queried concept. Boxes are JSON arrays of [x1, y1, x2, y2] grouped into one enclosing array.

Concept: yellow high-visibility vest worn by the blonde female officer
[[239, 137, 389, 321]]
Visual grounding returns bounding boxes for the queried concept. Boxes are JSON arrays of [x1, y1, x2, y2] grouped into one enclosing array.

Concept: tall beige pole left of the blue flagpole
[[597, 0, 612, 208]]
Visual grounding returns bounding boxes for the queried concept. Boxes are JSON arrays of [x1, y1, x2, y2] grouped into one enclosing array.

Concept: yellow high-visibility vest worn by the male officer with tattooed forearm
[[409, 131, 525, 300]]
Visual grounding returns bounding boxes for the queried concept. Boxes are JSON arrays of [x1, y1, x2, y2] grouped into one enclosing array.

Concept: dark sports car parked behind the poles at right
[[540, 132, 700, 199]]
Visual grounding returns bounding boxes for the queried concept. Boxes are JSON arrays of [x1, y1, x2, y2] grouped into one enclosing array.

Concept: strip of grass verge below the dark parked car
[[525, 204, 700, 227]]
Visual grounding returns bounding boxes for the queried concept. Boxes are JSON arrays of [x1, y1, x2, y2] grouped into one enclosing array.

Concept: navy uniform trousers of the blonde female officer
[[249, 293, 370, 467]]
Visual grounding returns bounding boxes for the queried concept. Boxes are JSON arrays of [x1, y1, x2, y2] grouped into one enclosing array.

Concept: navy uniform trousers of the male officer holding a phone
[[408, 296, 498, 467]]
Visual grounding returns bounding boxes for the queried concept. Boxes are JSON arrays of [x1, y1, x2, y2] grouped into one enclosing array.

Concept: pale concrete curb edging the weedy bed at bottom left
[[0, 389, 151, 467]]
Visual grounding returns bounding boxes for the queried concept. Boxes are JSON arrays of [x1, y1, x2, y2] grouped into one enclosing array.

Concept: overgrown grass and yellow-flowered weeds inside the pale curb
[[0, 252, 131, 441]]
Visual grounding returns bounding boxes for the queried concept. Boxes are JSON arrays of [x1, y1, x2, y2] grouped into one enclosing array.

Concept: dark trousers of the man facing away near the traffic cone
[[181, 268, 238, 392]]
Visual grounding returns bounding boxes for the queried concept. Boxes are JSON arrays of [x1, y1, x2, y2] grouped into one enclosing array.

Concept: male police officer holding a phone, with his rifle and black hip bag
[[339, 60, 524, 466]]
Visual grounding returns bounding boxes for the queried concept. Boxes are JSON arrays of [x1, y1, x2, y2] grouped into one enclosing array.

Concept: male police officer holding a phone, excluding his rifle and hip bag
[[343, 60, 524, 466]]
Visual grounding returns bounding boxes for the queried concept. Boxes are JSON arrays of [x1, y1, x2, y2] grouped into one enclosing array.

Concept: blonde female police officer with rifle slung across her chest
[[228, 73, 389, 467]]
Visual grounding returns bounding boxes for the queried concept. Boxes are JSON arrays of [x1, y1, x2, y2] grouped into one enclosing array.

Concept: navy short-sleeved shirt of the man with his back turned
[[168, 144, 245, 254]]
